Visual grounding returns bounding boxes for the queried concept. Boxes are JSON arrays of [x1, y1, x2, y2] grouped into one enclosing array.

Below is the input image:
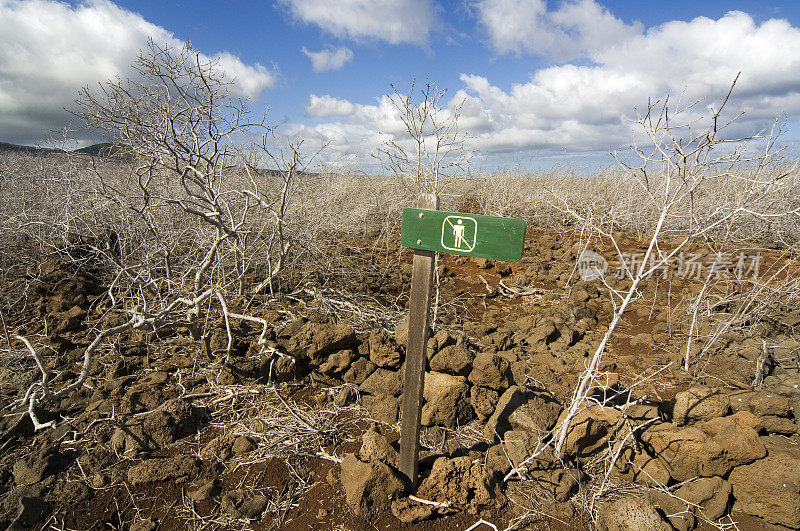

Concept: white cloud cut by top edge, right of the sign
[[475, 0, 642, 61]]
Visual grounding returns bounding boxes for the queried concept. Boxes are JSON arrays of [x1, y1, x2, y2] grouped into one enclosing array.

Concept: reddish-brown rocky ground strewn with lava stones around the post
[[0, 229, 800, 530]]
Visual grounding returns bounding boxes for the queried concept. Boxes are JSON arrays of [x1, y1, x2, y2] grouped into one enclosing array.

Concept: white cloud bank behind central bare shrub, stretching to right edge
[[296, 12, 800, 164]]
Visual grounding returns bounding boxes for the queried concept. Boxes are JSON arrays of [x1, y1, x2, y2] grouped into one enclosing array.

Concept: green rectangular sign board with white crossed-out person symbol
[[400, 208, 525, 262]]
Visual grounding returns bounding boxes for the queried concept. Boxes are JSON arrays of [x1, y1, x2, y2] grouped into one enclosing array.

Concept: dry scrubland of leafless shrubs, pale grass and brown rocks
[[0, 40, 800, 529]]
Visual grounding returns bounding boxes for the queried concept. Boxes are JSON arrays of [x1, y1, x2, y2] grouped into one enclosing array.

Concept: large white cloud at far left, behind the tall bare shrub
[[0, 0, 275, 144]]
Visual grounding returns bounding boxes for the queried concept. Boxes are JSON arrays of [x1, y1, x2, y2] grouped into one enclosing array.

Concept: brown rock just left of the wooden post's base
[[341, 454, 403, 518]]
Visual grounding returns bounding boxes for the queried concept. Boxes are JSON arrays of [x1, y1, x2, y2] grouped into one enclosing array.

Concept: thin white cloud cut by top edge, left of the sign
[[278, 0, 435, 46]]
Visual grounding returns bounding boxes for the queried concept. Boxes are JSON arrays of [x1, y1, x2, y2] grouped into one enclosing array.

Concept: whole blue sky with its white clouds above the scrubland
[[0, 0, 800, 168]]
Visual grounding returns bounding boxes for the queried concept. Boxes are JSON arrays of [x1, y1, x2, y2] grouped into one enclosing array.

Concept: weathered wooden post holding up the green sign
[[399, 194, 439, 488]]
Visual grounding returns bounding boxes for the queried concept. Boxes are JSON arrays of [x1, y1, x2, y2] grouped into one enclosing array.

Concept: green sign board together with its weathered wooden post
[[399, 201, 525, 488]]
